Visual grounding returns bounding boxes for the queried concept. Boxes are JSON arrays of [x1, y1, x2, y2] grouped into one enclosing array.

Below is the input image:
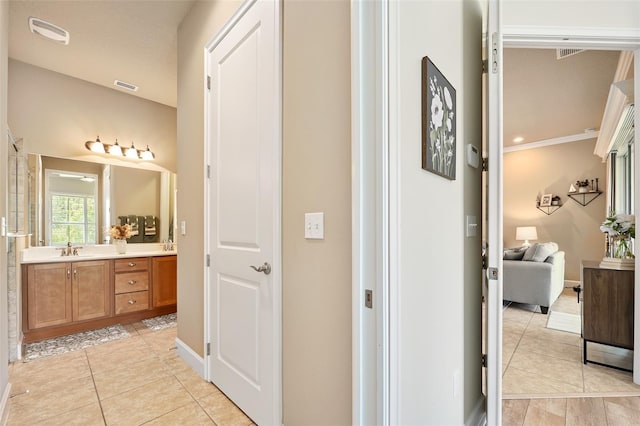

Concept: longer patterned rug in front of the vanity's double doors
[[23, 325, 131, 362]]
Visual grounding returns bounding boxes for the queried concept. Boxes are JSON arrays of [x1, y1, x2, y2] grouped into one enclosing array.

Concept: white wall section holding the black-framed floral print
[[389, 1, 482, 425]]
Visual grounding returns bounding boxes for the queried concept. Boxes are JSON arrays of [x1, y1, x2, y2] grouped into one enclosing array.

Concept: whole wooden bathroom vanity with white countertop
[[22, 244, 177, 343]]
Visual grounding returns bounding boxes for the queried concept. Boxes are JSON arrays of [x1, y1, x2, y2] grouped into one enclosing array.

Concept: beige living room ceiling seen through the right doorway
[[503, 49, 633, 147]]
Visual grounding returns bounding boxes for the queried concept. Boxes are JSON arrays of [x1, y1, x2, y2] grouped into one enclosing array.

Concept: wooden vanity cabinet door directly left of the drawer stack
[[72, 260, 112, 321]]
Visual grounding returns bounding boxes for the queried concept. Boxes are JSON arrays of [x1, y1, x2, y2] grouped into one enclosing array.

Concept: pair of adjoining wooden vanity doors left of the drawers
[[26, 260, 111, 329]]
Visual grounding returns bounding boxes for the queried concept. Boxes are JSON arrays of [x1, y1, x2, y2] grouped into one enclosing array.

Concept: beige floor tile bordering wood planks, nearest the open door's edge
[[502, 367, 583, 396]]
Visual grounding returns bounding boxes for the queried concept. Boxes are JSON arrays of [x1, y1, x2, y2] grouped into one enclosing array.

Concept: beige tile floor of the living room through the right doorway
[[502, 289, 640, 398]]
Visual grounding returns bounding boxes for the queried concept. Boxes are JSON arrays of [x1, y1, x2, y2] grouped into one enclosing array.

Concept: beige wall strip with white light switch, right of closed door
[[282, 0, 351, 425]]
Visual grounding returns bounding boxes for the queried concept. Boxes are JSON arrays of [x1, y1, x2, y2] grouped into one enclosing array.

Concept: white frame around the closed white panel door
[[202, 0, 282, 424]]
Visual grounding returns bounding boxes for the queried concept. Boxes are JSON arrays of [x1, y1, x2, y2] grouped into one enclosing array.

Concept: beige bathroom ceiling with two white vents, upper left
[[9, 0, 194, 107]]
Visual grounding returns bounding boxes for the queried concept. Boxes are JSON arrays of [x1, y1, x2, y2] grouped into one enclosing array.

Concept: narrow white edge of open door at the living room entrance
[[484, 0, 502, 425]]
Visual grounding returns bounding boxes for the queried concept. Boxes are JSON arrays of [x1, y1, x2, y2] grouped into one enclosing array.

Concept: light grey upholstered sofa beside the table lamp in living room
[[502, 243, 564, 314]]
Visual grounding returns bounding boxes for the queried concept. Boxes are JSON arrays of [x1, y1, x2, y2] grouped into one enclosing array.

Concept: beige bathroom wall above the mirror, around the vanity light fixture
[[9, 60, 176, 172]]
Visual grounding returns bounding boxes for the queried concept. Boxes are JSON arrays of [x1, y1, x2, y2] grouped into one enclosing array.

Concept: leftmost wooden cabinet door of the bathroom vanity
[[27, 263, 72, 329]]
